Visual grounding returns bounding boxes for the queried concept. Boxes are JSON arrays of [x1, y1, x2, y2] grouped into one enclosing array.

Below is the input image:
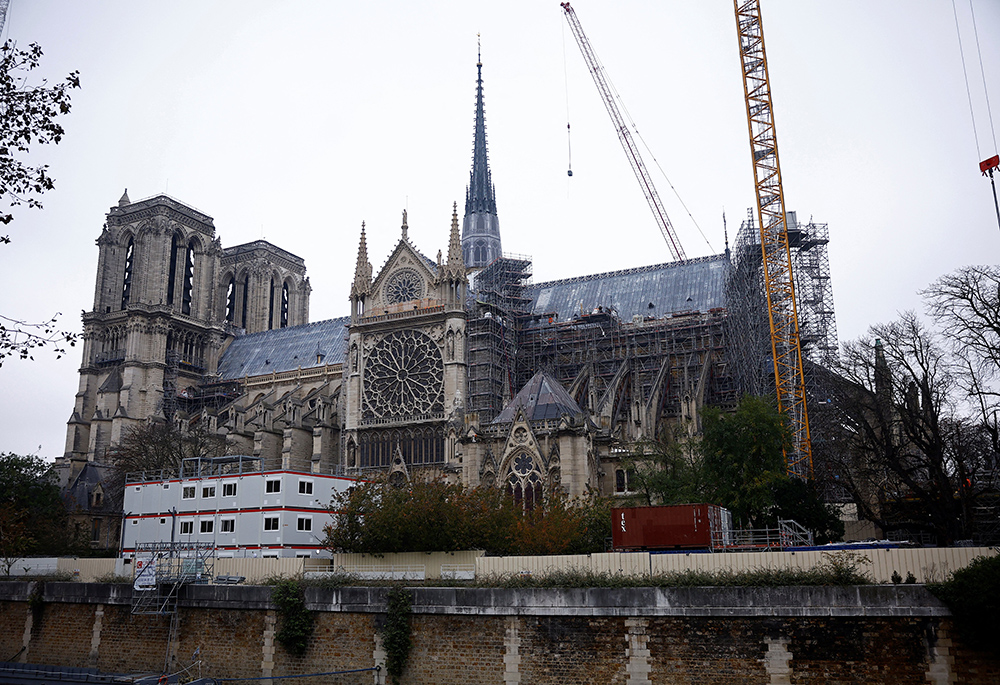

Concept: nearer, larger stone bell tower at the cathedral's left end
[[64, 191, 225, 461]]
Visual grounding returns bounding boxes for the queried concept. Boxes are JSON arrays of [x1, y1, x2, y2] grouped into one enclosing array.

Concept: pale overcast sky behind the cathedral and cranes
[[0, 0, 1000, 458]]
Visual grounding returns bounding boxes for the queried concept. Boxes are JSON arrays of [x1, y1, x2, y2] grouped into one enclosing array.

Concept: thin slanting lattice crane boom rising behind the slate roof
[[560, 2, 687, 262]]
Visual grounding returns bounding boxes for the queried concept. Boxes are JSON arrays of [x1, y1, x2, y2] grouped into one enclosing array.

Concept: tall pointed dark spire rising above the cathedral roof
[[462, 41, 501, 267]]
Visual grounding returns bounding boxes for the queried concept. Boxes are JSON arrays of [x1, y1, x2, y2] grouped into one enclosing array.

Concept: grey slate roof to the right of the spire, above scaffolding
[[524, 254, 729, 321]]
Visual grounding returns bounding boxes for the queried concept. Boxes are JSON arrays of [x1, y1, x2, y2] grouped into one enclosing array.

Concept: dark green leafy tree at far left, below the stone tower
[[0, 452, 78, 560]]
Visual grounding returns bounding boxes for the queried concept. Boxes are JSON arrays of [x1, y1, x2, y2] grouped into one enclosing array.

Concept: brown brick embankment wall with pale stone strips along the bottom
[[0, 582, 1000, 685]]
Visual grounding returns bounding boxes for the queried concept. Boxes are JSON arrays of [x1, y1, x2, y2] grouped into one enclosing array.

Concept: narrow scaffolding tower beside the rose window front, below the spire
[[466, 255, 531, 424]]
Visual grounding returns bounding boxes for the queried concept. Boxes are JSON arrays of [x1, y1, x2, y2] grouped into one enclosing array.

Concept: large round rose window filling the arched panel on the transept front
[[364, 331, 444, 420]]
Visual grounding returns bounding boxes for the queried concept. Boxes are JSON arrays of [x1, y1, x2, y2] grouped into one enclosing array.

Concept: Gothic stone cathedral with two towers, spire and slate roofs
[[64, 56, 737, 502]]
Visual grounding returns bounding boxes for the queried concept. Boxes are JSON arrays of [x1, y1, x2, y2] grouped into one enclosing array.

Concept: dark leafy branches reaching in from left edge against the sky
[[0, 40, 80, 365]]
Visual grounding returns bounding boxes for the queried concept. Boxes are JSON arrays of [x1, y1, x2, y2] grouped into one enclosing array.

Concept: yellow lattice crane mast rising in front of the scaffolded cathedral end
[[733, 0, 812, 478]]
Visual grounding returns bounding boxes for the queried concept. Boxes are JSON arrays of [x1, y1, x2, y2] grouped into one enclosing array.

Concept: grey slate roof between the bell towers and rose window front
[[219, 316, 351, 380]]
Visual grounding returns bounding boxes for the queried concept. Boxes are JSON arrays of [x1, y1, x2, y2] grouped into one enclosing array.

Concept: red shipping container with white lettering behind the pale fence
[[611, 504, 729, 551]]
